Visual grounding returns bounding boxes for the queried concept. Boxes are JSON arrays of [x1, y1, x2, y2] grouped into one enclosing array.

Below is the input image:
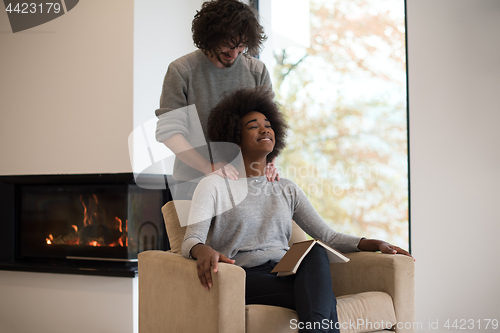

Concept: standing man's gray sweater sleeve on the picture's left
[[155, 63, 188, 142]]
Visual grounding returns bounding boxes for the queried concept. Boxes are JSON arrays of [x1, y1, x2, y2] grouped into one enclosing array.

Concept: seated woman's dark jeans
[[245, 245, 339, 333]]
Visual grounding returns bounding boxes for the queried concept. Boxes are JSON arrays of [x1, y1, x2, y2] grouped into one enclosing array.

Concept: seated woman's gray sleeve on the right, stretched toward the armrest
[[293, 184, 362, 253]]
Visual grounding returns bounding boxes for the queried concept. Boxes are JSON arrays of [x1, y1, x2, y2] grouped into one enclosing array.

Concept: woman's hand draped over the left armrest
[[191, 244, 234, 290]]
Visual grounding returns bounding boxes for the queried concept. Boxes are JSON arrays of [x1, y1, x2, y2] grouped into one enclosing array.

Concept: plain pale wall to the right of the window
[[407, 0, 500, 332]]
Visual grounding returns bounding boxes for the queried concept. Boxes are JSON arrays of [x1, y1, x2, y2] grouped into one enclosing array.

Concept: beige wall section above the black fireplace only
[[0, 0, 134, 175]]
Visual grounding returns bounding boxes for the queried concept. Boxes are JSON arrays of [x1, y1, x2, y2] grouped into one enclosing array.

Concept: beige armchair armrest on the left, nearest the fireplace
[[138, 251, 245, 333]]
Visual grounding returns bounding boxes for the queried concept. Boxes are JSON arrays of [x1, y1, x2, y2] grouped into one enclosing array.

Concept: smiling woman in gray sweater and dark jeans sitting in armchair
[[182, 88, 410, 332]]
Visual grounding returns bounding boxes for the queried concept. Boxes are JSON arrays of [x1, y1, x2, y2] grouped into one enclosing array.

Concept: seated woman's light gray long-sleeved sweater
[[182, 175, 361, 267]]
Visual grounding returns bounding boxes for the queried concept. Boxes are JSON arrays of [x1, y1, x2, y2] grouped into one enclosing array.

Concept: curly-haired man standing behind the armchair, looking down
[[156, 0, 279, 187]]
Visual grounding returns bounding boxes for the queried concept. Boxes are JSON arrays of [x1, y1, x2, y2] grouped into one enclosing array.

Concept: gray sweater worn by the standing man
[[156, 50, 271, 181]]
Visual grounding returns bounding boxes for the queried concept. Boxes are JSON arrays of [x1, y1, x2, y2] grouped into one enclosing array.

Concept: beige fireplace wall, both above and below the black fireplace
[[0, 0, 138, 333]]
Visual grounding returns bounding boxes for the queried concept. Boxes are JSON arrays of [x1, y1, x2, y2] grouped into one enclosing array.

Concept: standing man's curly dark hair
[[191, 0, 267, 56]]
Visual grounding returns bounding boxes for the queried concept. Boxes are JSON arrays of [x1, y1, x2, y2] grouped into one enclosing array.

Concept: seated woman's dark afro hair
[[208, 87, 288, 162]]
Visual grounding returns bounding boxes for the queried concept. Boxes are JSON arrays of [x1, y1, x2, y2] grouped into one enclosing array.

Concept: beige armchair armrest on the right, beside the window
[[330, 252, 415, 333]]
